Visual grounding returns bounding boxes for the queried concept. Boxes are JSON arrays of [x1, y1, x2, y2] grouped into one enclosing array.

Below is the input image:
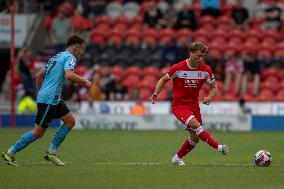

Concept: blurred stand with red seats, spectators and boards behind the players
[[0, 0, 284, 131]]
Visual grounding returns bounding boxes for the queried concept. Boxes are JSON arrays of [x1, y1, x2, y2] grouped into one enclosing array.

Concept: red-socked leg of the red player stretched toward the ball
[[188, 118, 229, 154]]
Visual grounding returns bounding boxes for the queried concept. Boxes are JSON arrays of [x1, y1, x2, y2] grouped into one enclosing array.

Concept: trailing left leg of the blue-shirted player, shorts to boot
[[2, 104, 51, 165]]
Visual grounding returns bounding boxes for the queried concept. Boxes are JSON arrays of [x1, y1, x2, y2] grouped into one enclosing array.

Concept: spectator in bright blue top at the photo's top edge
[[200, 0, 221, 17]]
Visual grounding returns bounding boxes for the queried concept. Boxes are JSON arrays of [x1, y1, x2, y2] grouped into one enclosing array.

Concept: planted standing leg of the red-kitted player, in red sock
[[172, 130, 199, 165]]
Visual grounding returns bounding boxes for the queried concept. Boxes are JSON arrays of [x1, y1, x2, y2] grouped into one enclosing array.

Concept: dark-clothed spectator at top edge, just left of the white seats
[[83, 0, 106, 17]]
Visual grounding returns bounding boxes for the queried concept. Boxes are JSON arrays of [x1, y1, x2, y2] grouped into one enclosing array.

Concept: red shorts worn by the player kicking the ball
[[172, 106, 202, 129]]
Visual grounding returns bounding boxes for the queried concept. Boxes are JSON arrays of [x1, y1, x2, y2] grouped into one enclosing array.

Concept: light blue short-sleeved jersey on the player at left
[[37, 51, 76, 105]]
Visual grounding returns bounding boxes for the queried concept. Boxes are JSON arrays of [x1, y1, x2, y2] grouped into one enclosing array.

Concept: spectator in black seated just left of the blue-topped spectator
[[174, 5, 197, 30]]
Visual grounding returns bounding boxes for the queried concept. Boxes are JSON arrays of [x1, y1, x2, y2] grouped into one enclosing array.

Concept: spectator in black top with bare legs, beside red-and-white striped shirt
[[241, 52, 260, 96]]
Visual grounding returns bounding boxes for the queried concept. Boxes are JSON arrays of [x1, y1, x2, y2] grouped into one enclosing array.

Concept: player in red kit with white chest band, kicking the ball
[[150, 42, 229, 165]]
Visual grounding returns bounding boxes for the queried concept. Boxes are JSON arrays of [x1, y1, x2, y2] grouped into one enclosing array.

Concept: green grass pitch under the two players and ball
[[0, 129, 284, 189]]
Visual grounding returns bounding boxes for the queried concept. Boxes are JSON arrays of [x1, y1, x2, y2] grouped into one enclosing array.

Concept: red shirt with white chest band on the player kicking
[[167, 60, 215, 106]]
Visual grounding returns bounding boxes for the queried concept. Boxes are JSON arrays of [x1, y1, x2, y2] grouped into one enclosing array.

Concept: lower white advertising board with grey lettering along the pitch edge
[[75, 114, 251, 131]]
